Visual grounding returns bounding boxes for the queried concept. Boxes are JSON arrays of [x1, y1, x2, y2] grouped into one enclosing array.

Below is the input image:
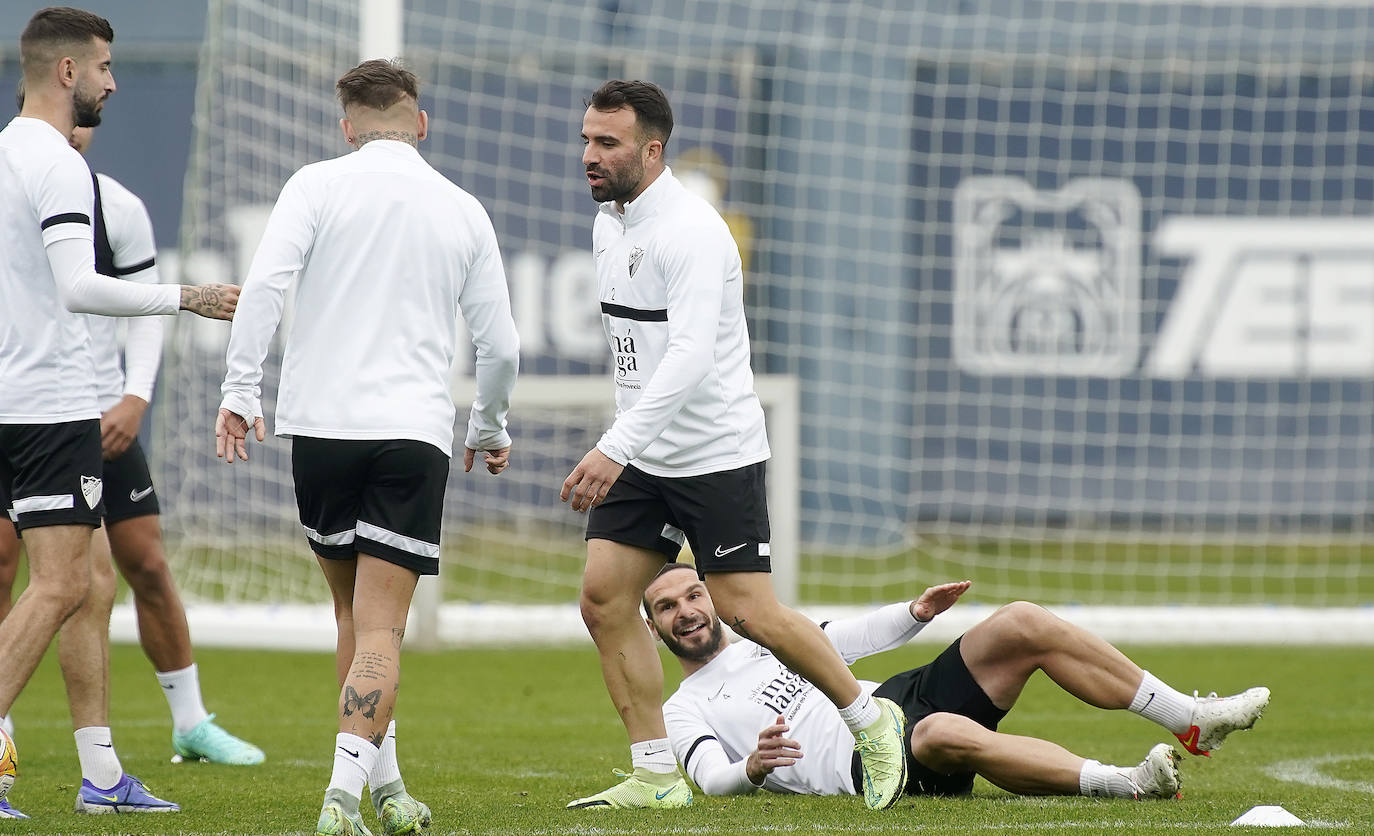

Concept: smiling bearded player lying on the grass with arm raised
[[644, 564, 1270, 799]]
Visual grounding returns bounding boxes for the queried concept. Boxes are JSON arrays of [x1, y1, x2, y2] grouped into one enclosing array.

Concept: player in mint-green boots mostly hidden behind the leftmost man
[[0, 111, 264, 765]]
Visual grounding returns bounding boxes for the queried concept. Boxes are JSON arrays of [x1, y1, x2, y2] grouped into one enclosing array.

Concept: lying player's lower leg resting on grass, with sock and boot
[[911, 714, 1182, 799]]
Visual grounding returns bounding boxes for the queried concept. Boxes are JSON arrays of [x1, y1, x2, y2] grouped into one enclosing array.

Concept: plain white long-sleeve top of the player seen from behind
[[221, 140, 519, 455]]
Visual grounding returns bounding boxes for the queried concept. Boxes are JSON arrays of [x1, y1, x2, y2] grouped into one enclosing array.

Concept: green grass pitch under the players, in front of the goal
[[0, 641, 1374, 835]]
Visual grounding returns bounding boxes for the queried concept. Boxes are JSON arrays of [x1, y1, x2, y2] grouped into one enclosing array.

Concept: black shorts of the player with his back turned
[[291, 436, 449, 575]]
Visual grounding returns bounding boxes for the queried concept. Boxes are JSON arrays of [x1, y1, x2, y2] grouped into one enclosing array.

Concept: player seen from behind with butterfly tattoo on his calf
[[216, 61, 519, 836]]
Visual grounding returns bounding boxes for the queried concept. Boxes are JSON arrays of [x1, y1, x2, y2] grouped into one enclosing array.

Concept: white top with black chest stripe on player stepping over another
[[592, 169, 769, 477]]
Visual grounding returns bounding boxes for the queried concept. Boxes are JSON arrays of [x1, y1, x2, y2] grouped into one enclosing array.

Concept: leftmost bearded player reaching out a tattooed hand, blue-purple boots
[[0, 7, 238, 813]]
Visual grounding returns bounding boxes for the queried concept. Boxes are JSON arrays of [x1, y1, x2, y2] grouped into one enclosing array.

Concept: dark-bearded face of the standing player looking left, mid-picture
[[583, 106, 664, 206]]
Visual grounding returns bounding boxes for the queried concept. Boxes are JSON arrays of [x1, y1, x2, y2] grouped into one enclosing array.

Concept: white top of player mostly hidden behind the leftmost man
[[88, 175, 162, 413]]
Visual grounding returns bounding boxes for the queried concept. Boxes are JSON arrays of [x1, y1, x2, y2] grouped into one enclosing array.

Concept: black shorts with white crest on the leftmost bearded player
[[0, 418, 104, 531]]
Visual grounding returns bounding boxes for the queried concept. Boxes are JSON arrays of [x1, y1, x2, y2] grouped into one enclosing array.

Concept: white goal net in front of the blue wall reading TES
[[155, 0, 1374, 646]]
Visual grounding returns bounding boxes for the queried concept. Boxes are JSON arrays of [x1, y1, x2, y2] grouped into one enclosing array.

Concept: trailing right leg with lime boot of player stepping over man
[[706, 572, 907, 809]]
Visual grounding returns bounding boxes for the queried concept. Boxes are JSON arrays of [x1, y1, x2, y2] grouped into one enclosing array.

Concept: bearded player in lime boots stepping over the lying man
[[562, 81, 907, 809]]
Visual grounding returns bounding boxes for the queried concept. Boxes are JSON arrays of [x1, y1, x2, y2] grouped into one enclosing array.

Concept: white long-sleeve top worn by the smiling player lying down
[[664, 604, 929, 795]]
